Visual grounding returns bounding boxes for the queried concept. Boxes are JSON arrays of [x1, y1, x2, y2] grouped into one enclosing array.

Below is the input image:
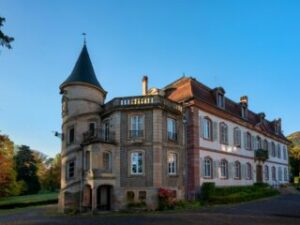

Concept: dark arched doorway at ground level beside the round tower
[[97, 185, 112, 210]]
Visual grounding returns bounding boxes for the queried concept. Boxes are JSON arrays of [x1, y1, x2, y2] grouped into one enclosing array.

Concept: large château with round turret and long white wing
[[59, 44, 288, 211]]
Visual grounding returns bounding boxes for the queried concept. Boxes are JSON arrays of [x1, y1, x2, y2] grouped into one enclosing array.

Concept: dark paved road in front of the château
[[0, 194, 300, 225]]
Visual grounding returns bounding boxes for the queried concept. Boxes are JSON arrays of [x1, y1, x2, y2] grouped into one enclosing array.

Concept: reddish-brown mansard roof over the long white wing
[[164, 77, 287, 141]]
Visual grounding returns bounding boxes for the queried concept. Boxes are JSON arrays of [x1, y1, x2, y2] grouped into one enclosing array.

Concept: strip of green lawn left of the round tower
[[0, 192, 58, 209]]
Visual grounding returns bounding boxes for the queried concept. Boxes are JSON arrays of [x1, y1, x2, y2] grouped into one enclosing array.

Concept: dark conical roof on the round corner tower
[[60, 44, 106, 94]]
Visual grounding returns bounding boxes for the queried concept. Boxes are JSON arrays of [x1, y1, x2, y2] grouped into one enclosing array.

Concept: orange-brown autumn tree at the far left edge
[[0, 135, 19, 197]]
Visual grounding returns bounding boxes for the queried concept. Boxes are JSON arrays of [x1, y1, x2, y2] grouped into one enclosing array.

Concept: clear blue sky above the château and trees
[[0, 0, 300, 156]]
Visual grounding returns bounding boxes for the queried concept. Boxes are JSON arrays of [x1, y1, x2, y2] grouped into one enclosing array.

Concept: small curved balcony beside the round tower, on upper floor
[[83, 129, 116, 145]]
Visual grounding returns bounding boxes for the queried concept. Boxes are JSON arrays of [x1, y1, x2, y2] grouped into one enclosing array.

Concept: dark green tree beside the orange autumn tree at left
[[15, 145, 41, 194]]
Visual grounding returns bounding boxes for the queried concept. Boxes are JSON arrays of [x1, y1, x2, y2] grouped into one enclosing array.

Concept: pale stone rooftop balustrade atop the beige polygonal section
[[104, 95, 182, 113]]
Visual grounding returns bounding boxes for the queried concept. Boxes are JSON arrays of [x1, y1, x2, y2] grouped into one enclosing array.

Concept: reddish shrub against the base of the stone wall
[[158, 188, 176, 210]]
